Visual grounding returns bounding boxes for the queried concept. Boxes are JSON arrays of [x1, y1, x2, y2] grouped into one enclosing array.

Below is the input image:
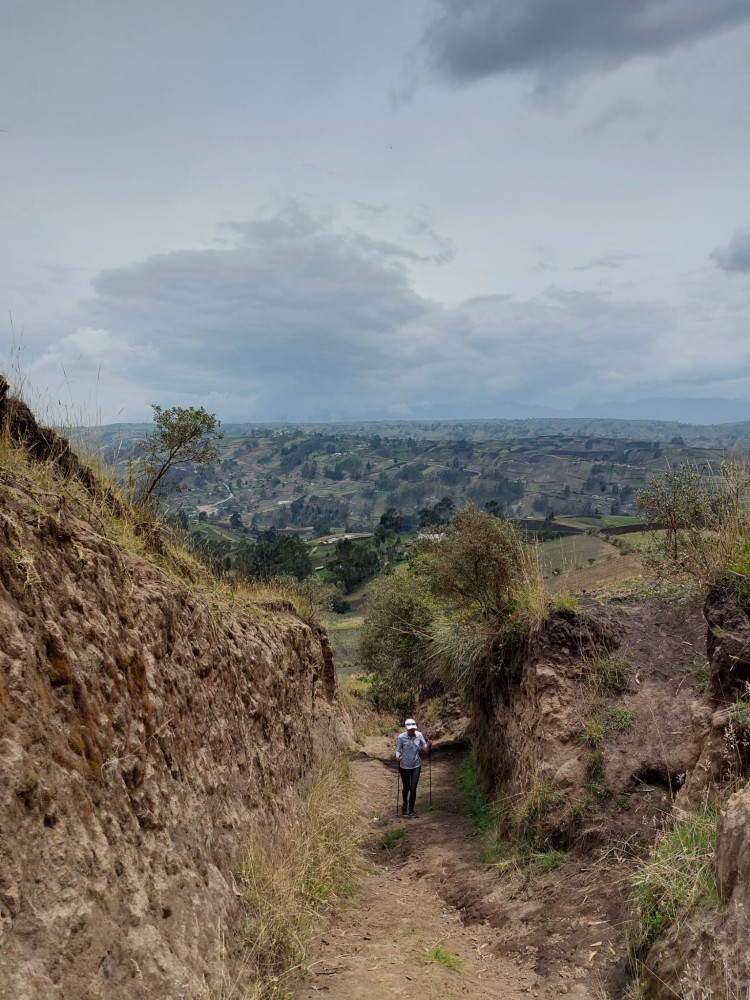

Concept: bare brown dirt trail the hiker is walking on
[[295, 737, 601, 1000]]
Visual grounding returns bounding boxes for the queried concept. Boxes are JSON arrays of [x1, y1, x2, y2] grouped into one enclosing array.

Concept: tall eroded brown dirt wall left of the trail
[[0, 477, 347, 1000]]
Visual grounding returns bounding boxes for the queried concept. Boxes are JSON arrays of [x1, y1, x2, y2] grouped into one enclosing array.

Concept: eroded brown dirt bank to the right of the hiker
[[474, 599, 707, 841]]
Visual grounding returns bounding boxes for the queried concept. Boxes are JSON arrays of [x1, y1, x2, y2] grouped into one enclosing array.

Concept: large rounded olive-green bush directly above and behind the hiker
[[360, 507, 549, 711]]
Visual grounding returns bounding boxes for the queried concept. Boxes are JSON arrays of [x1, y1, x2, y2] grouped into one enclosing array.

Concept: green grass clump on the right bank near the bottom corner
[[628, 811, 719, 958]]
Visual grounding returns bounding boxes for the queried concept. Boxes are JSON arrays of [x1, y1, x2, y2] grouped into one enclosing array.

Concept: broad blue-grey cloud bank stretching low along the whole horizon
[[33, 206, 750, 421]]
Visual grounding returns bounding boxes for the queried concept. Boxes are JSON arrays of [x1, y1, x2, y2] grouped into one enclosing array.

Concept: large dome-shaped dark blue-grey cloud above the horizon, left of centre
[[72, 206, 434, 418]]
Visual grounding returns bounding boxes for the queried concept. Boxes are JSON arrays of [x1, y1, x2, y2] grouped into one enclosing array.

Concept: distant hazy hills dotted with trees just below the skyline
[[79, 418, 750, 546]]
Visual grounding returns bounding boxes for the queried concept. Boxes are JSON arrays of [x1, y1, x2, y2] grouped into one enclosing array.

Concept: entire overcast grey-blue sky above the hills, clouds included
[[0, 0, 750, 423]]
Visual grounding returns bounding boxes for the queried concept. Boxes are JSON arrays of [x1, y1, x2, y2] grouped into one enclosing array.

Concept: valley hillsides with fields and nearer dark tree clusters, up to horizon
[[82, 421, 748, 612]]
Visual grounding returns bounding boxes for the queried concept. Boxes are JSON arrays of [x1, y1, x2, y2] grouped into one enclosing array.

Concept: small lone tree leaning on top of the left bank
[[136, 404, 222, 507]]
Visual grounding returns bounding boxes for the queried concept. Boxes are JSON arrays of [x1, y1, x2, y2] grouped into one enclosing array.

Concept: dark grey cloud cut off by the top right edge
[[425, 0, 750, 81]]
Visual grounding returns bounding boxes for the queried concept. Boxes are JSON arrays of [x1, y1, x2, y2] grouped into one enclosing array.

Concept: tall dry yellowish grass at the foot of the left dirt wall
[[235, 758, 361, 996]]
